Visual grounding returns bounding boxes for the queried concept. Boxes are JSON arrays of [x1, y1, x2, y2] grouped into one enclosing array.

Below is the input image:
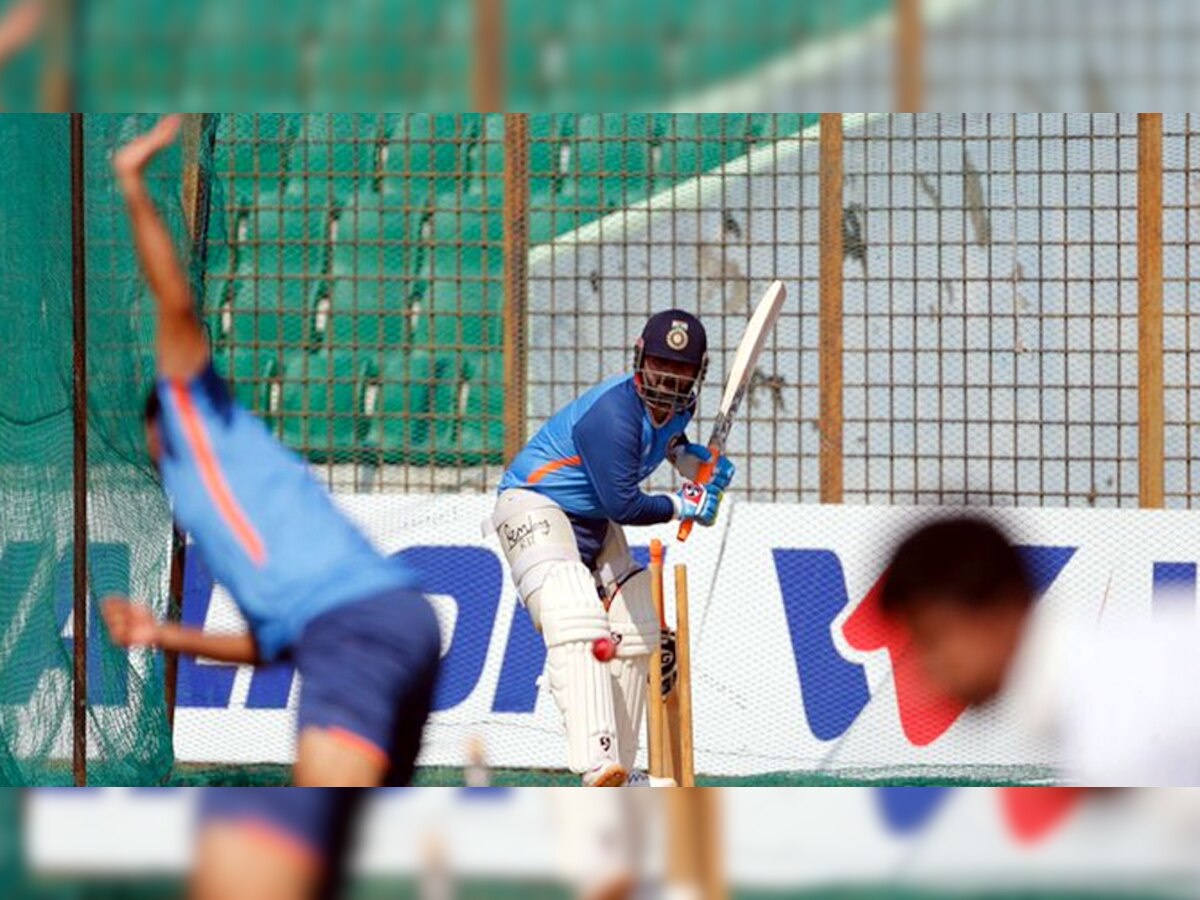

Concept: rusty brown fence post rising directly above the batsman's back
[[503, 113, 529, 463]]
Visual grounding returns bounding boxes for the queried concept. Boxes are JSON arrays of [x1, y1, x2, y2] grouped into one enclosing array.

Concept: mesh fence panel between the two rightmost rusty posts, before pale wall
[[844, 114, 1138, 505]]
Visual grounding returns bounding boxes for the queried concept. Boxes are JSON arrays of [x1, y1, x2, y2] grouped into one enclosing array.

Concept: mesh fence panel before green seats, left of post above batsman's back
[[204, 114, 503, 490]]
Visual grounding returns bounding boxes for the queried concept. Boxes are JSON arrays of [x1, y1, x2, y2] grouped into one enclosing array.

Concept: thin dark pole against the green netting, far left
[[71, 113, 88, 786]]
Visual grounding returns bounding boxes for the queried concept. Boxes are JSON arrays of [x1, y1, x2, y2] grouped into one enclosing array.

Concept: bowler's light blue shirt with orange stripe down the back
[[157, 364, 416, 660]]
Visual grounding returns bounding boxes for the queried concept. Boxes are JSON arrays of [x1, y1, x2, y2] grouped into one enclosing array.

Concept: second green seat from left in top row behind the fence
[[287, 113, 376, 206]]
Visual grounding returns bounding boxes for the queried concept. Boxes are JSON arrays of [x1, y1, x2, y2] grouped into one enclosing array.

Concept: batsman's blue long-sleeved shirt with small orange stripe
[[500, 374, 692, 526]]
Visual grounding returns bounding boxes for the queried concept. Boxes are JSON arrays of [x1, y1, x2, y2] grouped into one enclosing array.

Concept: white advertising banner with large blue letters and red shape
[[175, 496, 1200, 779]]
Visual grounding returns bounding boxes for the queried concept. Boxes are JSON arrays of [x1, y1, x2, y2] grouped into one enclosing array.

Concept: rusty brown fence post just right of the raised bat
[[818, 113, 844, 503]]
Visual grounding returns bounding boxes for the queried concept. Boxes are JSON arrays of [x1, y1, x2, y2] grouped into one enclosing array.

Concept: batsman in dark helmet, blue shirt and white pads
[[484, 310, 734, 787]]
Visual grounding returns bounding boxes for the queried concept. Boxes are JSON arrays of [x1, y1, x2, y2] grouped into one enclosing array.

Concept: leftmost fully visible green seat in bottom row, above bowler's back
[[280, 347, 378, 462]]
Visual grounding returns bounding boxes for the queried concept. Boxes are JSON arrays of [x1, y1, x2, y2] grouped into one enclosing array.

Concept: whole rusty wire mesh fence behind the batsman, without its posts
[[189, 114, 1180, 506]]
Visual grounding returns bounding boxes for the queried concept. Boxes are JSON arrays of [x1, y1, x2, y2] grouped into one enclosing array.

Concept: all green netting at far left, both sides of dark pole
[[0, 116, 185, 785]]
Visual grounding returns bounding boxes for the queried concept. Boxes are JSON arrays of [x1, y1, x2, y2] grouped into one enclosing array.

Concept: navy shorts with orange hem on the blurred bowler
[[292, 590, 442, 786]]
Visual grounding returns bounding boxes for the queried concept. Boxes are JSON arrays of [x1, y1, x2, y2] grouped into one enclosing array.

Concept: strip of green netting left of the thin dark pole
[[0, 115, 72, 784]]
